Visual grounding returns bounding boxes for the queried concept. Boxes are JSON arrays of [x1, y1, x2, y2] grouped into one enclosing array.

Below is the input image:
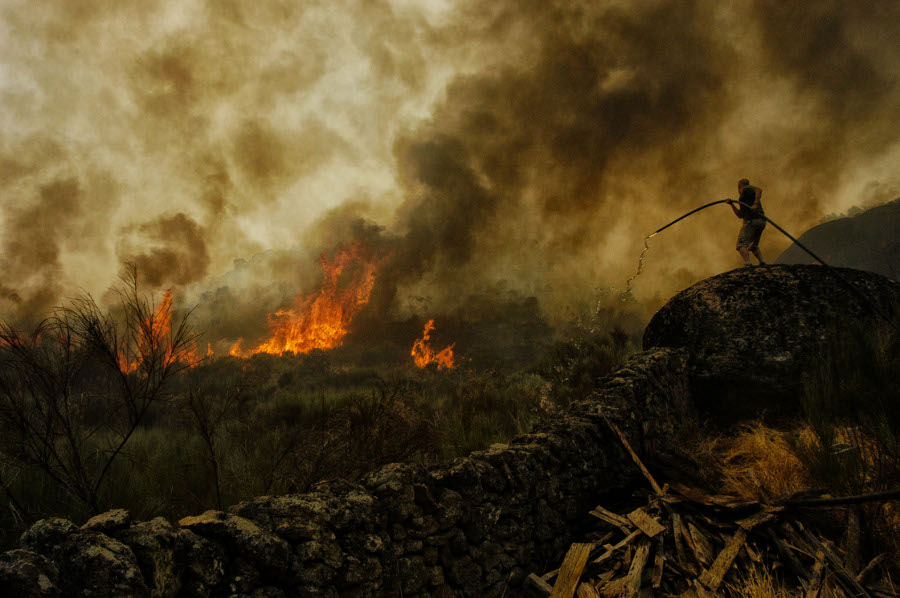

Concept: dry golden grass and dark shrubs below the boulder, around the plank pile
[[677, 331, 900, 598]]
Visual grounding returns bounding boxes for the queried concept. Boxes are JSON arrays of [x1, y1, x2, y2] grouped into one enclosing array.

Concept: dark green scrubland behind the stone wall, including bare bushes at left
[[0, 276, 635, 548]]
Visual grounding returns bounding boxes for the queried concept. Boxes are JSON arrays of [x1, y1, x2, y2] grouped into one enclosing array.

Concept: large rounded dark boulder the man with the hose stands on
[[643, 265, 900, 421]]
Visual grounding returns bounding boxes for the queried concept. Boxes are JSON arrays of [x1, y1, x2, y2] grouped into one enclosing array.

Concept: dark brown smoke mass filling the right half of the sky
[[366, 2, 900, 322]]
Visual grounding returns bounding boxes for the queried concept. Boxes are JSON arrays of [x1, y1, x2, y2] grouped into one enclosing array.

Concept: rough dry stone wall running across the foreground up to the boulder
[[0, 349, 694, 598]]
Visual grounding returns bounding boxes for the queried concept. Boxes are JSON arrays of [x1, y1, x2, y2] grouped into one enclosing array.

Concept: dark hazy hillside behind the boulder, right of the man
[[776, 198, 900, 280]]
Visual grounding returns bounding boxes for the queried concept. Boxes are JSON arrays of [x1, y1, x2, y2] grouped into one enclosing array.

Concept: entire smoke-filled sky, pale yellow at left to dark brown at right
[[0, 0, 900, 336]]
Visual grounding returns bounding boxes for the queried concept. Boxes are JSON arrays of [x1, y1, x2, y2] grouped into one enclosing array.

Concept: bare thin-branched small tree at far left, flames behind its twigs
[[0, 265, 196, 513]]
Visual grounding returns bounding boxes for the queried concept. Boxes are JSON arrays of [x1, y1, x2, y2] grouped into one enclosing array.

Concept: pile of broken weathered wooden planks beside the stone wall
[[525, 488, 900, 598]]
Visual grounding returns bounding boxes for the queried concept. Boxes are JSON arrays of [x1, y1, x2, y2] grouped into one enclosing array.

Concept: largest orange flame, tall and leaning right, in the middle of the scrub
[[228, 243, 377, 357]]
